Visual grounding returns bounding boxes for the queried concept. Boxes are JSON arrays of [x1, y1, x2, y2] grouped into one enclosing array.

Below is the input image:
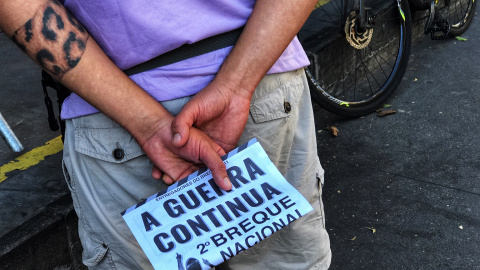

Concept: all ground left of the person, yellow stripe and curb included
[[0, 30, 79, 269]]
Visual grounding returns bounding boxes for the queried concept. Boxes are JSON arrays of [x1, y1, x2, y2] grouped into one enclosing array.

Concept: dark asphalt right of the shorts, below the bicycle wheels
[[316, 17, 480, 270]]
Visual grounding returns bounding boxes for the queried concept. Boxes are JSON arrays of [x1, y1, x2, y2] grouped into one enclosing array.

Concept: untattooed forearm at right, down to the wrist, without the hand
[[216, 0, 317, 94]]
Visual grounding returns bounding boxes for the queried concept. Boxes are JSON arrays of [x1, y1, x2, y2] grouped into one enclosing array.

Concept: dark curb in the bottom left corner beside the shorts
[[0, 193, 86, 270]]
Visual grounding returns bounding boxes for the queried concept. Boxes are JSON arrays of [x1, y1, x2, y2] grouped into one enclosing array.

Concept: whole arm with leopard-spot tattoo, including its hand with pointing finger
[[0, 0, 230, 189]]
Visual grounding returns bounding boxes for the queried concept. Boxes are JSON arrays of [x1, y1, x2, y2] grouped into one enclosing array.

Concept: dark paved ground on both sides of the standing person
[[0, 7, 480, 269]]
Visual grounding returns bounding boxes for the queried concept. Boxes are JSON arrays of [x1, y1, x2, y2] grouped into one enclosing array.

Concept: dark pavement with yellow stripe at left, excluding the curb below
[[0, 33, 66, 240]]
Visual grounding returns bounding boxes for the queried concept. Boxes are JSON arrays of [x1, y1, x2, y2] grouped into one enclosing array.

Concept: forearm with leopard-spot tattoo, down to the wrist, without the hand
[[0, 0, 171, 144]]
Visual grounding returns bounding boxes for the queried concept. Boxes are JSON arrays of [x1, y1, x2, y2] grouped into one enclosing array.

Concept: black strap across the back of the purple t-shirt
[[123, 27, 243, 76]]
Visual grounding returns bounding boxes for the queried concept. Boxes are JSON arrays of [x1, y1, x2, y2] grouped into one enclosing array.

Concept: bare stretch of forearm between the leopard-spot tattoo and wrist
[[62, 39, 172, 145]]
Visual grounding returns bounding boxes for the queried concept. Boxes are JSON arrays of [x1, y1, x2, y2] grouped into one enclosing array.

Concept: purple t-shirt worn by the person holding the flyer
[[62, 0, 309, 119]]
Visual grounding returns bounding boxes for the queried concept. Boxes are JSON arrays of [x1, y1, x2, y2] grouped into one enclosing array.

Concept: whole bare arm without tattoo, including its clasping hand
[[172, 0, 317, 151]]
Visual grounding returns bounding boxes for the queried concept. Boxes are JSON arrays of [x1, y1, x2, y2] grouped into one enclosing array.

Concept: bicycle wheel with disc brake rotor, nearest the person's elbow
[[298, 0, 411, 117]]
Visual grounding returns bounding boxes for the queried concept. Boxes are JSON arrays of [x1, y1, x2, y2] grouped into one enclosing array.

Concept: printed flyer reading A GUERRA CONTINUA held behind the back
[[122, 139, 312, 270]]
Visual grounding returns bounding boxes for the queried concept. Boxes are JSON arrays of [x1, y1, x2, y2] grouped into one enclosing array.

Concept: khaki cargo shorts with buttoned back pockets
[[63, 69, 331, 270]]
